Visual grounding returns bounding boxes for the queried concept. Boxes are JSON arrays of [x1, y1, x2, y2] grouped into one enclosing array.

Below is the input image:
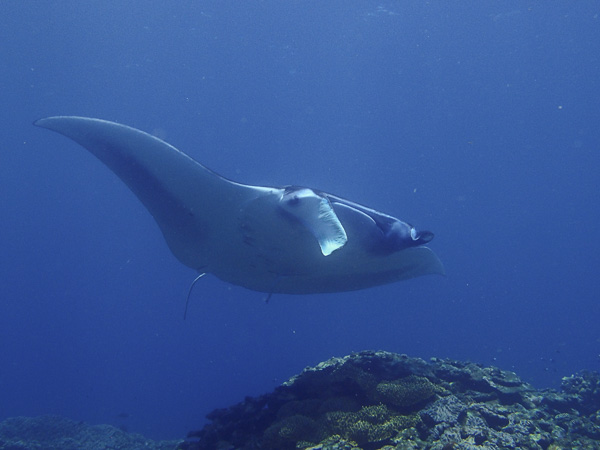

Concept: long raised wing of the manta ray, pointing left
[[35, 116, 262, 270]]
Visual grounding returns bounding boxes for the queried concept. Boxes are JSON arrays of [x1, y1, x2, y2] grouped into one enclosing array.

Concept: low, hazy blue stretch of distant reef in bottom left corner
[[0, 416, 178, 450]]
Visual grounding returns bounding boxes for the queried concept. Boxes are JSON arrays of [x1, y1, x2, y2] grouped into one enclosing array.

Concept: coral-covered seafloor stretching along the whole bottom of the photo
[[0, 351, 600, 450]]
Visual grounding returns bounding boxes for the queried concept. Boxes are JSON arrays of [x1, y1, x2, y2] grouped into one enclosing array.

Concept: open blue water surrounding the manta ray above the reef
[[0, 0, 600, 438]]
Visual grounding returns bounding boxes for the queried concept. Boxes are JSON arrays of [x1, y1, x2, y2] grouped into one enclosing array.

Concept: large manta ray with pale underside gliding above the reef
[[34, 116, 444, 296]]
